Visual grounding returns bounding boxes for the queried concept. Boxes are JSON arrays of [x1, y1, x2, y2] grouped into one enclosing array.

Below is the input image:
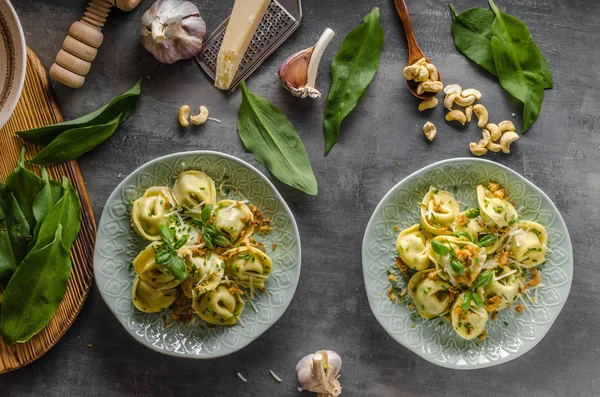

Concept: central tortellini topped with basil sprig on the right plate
[[427, 236, 486, 286]]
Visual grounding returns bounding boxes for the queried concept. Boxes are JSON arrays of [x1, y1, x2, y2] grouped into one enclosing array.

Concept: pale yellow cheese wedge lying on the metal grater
[[215, 0, 271, 90]]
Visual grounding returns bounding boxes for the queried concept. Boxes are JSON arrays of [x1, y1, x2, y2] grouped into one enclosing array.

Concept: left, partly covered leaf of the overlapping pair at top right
[[450, 4, 496, 75]]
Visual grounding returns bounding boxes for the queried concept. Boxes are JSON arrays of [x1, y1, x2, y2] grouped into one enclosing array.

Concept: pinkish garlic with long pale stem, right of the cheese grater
[[277, 28, 335, 99]]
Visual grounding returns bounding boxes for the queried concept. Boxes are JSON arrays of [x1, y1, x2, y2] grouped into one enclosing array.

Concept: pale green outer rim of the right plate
[[361, 157, 574, 370]]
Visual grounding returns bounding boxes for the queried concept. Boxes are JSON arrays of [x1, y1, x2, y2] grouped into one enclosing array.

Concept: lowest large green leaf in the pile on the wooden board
[[0, 224, 71, 344]]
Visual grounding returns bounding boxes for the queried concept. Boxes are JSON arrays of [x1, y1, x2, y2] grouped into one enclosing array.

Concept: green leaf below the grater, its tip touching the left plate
[[238, 81, 317, 195]]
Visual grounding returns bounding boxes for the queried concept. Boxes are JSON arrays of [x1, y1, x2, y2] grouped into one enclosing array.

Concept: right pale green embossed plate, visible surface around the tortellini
[[362, 158, 573, 369]]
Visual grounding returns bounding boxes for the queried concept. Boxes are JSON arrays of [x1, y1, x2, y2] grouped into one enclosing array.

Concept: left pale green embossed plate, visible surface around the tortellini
[[94, 151, 300, 359]]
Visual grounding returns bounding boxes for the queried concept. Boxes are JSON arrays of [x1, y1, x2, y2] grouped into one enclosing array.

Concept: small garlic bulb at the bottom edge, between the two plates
[[296, 350, 342, 397]]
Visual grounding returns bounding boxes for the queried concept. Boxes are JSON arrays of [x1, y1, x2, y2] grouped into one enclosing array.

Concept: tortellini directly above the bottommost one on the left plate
[[180, 248, 225, 299]]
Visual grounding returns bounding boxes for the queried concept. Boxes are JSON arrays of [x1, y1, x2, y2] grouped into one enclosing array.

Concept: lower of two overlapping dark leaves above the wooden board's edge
[[29, 117, 119, 165]]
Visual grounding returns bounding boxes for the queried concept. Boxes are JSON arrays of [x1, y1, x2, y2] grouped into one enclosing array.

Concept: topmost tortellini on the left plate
[[172, 171, 217, 209]]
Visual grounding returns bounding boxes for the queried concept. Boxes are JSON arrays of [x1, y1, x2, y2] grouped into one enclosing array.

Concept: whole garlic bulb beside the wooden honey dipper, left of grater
[[140, 0, 206, 63]]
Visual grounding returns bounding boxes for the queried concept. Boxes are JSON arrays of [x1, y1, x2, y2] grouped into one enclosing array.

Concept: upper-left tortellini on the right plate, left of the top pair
[[421, 186, 460, 235]]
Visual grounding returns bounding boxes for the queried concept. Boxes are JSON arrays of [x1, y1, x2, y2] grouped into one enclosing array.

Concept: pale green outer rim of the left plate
[[94, 150, 302, 360]]
